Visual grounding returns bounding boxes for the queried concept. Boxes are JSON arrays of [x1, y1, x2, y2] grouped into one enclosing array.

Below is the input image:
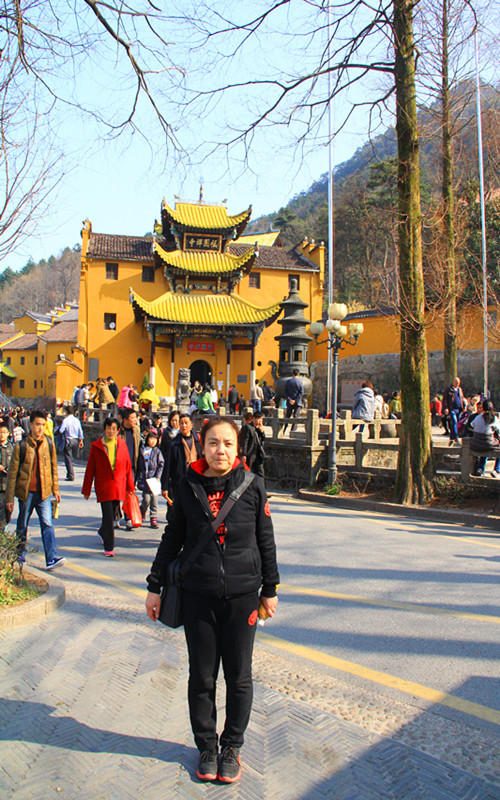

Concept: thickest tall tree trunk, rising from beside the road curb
[[394, 0, 433, 504]]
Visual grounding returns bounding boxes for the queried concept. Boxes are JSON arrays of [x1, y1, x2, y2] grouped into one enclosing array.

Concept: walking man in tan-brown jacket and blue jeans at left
[[5, 409, 66, 569]]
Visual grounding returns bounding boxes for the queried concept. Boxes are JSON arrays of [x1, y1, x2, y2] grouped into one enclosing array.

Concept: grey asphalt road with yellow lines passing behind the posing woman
[[20, 466, 500, 730]]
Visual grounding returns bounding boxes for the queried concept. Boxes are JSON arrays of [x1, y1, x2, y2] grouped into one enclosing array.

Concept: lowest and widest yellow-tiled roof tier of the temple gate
[[134, 292, 280, 325]]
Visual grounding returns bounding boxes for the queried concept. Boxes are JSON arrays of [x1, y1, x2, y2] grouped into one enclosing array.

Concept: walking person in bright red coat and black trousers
[[82, 417, 134, 556]]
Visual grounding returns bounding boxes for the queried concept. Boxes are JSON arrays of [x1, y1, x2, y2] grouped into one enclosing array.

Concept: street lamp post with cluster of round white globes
[[310, 303, 364, 486]]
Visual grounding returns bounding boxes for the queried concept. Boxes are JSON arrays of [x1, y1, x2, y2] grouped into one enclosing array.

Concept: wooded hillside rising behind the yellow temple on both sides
[[0, 84, 500, 322]]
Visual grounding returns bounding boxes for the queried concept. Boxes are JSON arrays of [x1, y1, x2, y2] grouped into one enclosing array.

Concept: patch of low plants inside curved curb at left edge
[[0, 530, 48, 608]]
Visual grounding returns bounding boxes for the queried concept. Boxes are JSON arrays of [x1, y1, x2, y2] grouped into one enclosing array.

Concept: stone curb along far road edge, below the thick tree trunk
[[298, 489, 500, 531]]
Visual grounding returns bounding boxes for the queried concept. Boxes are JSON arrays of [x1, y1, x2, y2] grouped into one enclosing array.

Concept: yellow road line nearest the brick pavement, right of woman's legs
[[258, 631, 500, 725]]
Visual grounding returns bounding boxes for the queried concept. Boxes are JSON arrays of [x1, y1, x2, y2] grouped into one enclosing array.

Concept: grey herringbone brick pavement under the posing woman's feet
[[0, 583, 500, 800]]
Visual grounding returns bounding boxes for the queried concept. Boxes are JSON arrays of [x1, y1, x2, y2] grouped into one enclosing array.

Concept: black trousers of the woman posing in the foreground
[[184, 591, 258, 751]]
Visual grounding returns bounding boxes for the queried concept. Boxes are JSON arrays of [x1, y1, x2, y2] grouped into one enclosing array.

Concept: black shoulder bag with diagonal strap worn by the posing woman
[[158, 472, 255, 628]]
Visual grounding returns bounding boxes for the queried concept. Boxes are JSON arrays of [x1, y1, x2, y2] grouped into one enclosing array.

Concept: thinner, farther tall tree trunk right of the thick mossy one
[[441, 0, 457, 386]]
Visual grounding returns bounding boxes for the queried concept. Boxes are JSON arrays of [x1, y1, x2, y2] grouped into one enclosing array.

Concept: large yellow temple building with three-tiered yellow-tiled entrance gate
[[78, 195, 324, 399]]
